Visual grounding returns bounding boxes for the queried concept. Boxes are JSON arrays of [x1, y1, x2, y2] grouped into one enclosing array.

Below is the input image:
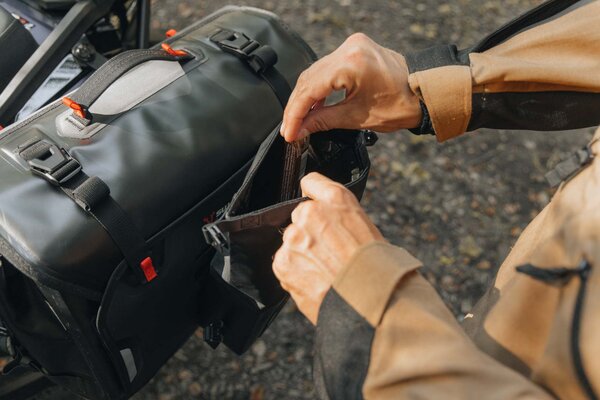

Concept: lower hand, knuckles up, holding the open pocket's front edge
[[273, 172, 385, 325]]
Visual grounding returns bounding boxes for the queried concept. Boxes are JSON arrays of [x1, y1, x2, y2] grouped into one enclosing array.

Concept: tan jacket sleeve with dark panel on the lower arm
[[314, 243, 551, 400]]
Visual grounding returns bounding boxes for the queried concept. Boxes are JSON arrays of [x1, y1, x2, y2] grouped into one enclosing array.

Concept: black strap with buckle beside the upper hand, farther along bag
[[210, 29, 292, 108]]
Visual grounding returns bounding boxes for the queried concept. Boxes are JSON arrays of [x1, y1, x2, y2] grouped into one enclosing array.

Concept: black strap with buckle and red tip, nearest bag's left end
[[19, 139, 157, 282]]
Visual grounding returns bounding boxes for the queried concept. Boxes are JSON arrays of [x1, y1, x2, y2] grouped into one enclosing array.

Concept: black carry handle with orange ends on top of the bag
[[62, 43, 194, 126]]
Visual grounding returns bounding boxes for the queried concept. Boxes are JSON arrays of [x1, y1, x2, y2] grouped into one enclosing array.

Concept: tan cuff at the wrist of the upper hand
[[408, 65, 473, 142]]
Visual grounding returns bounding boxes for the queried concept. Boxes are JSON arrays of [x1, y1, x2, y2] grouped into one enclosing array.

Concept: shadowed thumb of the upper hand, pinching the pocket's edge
[[292, 104, 356, 140]]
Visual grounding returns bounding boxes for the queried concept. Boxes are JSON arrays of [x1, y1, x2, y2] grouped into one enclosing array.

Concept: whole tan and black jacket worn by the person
[[315, 0, 600, 400]]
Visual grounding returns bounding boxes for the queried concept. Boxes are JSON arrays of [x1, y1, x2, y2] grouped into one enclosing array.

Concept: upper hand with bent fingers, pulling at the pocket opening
[[281, 33, 422, 142]]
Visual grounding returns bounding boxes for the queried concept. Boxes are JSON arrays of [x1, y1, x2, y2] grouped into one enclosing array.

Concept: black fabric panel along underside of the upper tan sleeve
[[467, 92, 600, 131]]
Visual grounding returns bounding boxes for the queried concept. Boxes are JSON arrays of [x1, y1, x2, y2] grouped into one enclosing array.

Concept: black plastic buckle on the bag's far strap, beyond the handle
[[210, 29, 277, 74]]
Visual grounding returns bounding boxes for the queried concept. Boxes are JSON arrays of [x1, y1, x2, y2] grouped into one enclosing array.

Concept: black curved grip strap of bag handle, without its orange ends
[[70, 48, 192, 122]]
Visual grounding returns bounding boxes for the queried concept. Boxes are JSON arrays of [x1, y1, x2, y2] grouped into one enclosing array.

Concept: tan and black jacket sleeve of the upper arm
[[406, 0, 600, 141]]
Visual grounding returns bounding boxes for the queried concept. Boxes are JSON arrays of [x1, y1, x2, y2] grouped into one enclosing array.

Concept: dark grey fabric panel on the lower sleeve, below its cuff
[[314, 289, 375, 400]]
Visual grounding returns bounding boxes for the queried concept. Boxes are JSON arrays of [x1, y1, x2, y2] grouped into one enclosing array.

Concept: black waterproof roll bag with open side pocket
[[0, 3, 368, 399]]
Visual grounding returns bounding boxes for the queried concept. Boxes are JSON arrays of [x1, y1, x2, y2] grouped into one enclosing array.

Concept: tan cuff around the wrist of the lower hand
[[333, 242, 422, 326]]
